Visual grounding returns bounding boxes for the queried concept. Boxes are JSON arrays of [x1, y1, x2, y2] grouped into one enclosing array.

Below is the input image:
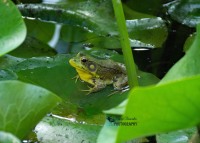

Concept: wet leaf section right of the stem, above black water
[[126, 17, 168, 48]]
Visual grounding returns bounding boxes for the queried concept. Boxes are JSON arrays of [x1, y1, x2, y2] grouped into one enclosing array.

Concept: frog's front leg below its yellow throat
[[82, 78, 106, 94]]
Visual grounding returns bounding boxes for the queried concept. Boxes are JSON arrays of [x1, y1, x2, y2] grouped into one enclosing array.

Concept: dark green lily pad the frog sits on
[[0, 50, 158, 114]]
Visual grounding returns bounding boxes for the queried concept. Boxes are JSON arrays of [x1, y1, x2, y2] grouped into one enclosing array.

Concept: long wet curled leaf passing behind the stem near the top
[[18, 1, 167, 49]]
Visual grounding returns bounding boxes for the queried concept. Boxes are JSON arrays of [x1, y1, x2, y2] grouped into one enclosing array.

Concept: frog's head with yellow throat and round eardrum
[[69, 52, 98, 75]]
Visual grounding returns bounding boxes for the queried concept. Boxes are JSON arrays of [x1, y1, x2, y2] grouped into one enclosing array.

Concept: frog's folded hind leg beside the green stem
[[113, 74, 128, 90]]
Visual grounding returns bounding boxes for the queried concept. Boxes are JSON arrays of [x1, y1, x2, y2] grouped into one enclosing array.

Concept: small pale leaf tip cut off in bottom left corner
[[0, 131, 21, 143]]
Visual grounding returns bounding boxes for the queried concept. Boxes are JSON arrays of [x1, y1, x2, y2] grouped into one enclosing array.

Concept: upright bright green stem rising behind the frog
[[112, 0, 139, 88]]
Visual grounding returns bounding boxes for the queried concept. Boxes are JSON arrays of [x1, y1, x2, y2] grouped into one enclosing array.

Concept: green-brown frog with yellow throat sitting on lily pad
[[69, 52, 128, 94]]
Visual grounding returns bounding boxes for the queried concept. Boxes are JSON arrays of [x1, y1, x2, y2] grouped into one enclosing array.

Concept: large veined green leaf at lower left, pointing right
[[0, 80, 60, 139]]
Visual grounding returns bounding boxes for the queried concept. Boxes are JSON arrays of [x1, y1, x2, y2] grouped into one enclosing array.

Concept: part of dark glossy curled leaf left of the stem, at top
[[18, 1, 116, 35]]
